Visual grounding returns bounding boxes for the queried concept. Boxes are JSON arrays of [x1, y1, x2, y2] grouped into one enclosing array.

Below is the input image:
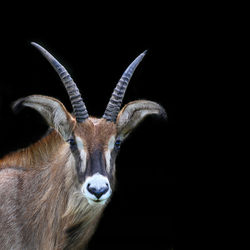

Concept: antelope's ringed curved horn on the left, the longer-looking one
[[31, 42, 89, 123]]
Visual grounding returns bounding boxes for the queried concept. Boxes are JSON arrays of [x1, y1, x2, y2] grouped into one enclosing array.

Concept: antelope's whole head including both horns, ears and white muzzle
[[13, 43, 166, 205]]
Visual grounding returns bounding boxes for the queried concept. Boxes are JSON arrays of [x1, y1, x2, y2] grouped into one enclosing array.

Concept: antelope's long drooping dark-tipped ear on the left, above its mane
[[12, 95, 76, 141]]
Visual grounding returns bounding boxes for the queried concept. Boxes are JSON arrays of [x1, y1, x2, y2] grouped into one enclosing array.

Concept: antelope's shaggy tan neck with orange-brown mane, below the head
[[0, 131, 104, 249]]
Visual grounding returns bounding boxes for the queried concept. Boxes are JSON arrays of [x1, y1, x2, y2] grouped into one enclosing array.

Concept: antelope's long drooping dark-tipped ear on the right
[[116, 100, 167, 139]]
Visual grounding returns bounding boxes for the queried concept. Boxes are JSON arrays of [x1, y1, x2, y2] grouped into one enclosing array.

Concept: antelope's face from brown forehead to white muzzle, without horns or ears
[[70, 118, 116, 204]]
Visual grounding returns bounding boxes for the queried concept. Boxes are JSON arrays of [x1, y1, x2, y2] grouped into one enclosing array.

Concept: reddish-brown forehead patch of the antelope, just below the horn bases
[[75, 117, 116, 148]]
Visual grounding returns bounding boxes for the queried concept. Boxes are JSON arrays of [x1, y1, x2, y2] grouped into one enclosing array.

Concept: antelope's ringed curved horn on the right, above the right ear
[[102, 50, 147, 122]]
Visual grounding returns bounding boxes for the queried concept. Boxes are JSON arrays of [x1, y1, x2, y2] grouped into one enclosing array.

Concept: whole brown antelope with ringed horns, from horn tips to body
[[0, 42, 166, 250]]
